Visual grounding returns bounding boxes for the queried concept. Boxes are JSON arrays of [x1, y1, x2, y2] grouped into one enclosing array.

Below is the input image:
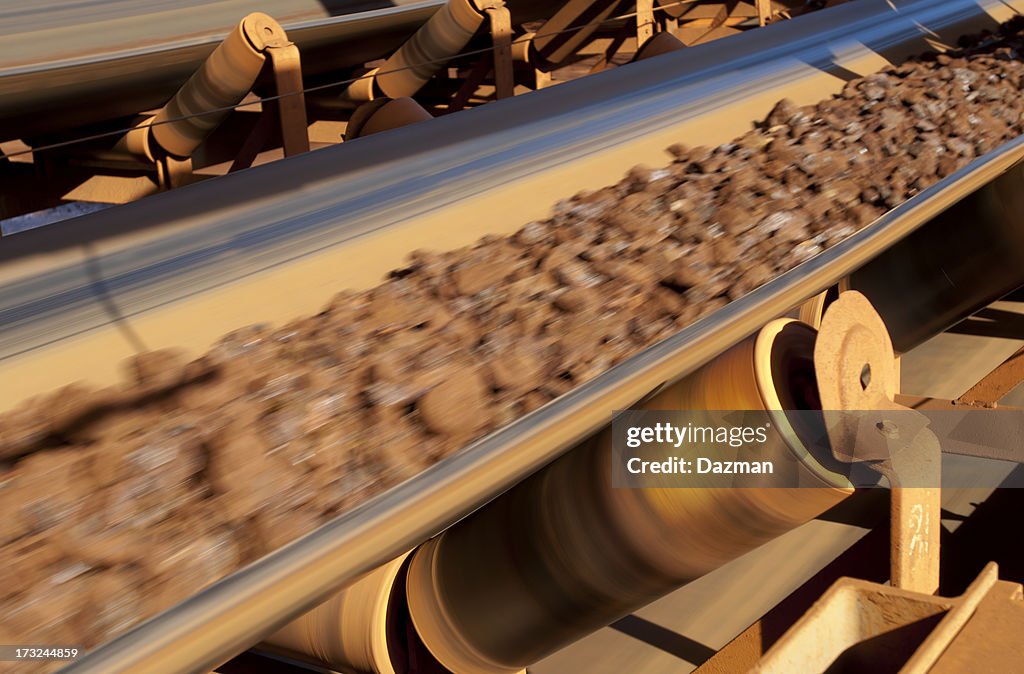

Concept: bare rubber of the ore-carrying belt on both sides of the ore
[[0, 0, 1024, 672]]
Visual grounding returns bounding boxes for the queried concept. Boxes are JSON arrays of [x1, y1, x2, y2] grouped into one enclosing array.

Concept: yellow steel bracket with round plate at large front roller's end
[[814, 291, 941, 593]]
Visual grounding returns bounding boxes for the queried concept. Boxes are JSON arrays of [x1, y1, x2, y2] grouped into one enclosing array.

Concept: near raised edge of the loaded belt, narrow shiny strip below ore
[[54, 138, 1024, 674]]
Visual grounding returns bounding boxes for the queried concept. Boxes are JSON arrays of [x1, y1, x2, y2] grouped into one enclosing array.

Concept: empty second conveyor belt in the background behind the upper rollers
[[0, 0, 546, 140]]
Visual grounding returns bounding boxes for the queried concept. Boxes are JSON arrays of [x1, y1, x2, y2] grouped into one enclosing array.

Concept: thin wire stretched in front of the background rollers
[[0, 0, 712, 159]]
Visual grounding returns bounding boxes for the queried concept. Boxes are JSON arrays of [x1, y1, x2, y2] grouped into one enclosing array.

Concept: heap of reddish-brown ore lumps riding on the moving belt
[[0, 18, 1024, 659]]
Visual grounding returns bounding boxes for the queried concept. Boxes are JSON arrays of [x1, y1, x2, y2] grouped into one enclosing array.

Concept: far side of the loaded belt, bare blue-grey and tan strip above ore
[[0, 0, 1012, 407]]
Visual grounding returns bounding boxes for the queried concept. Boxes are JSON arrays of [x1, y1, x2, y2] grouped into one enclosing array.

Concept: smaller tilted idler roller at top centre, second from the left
[[347, 0, 483, 100]]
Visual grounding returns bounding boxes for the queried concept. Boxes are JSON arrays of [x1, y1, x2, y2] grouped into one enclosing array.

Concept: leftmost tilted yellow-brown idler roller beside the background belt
[[150, 12, 288, 157]]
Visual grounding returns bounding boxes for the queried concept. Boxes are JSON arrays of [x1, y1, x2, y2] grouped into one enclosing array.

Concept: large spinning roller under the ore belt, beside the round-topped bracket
[[407, 320, 852, 674]]
